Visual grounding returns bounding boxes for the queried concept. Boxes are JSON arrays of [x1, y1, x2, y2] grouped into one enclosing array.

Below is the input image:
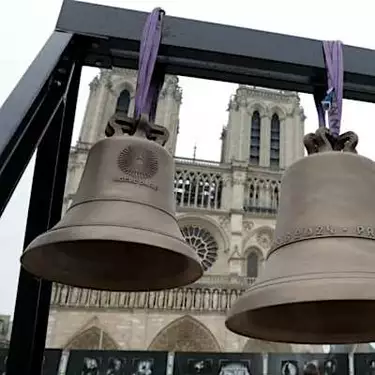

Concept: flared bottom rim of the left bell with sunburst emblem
[[21, 225, 204, 292]]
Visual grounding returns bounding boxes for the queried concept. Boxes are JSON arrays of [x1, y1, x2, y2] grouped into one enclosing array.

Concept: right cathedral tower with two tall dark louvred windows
[[222, 85, 305, 170]]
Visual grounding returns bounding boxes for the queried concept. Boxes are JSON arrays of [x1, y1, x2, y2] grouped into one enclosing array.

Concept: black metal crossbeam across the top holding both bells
[[57, 0, 375, 102]]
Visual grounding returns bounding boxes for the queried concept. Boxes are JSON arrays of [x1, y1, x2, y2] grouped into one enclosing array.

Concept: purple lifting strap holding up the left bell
[[134, 8, 165, 122]]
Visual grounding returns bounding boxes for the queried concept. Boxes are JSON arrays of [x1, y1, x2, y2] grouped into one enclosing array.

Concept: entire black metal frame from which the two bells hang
[[0, 0, 375, 375]]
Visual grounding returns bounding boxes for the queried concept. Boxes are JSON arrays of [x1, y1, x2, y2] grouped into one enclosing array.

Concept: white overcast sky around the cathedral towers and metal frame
[[0, 0, 375, 314]]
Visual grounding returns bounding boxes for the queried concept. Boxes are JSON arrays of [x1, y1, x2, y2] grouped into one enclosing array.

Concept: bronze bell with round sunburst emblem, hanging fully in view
[[21, 118, 203, 291]]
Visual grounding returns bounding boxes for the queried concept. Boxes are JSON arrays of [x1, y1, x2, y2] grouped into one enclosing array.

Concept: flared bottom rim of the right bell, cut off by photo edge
[[225, 272, 375, 344]]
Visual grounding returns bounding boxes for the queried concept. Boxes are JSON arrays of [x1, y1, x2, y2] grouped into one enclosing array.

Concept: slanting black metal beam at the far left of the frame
[[0, 32, 73, 215]]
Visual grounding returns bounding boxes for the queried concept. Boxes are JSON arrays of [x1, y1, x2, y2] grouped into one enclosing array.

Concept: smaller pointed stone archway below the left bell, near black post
[[65, 326, 118, 350]]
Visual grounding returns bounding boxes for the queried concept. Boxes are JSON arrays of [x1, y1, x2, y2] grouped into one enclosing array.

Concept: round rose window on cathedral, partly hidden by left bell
[[181, 225, 218, 271]]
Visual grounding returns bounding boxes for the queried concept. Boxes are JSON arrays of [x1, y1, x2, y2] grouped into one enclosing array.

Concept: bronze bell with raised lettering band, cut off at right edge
[[226, 128, 375, 344]]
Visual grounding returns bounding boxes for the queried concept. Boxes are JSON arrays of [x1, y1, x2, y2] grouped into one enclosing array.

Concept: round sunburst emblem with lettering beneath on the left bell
[[114, 145, 159, 190]]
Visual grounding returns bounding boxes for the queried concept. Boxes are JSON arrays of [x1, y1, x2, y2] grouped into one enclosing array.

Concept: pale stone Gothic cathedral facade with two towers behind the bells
[[47, 69, 321, 352]]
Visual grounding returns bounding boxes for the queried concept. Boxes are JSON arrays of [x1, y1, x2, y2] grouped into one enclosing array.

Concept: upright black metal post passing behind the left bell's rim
[[6, 62, 82, 375]]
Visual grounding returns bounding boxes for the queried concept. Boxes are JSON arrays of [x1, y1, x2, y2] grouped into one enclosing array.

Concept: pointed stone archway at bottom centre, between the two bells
[[148, 315, 221, 352]]
